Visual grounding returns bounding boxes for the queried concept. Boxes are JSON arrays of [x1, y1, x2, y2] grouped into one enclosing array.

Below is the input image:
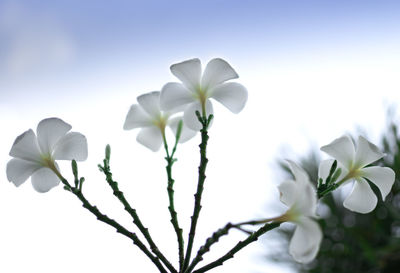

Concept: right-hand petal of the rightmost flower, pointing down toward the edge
[[361, 166, 395, 200]]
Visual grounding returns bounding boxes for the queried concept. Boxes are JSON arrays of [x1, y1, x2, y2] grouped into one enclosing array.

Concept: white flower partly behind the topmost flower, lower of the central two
[[124, 91, 196, 152]]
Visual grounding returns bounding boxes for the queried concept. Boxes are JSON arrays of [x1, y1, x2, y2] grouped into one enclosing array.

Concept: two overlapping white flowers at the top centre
[[124, 58, 247, 151]]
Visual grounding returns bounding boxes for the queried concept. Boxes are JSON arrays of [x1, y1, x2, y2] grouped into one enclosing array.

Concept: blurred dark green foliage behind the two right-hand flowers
[[268, 116, 400, 273]]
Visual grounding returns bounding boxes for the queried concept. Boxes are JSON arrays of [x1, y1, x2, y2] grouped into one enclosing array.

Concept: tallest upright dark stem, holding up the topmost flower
[[183, 112, 213, 271]]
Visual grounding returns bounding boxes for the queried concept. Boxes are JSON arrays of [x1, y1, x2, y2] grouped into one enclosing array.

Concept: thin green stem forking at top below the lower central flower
[[163, 135, 184, 272]]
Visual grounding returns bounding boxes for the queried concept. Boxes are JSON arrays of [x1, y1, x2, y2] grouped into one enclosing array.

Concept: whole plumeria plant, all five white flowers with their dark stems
[[6, 58, 395, 273]]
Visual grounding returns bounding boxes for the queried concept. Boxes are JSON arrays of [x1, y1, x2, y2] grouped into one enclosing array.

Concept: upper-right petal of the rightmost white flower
[[355, 136, 385, 167]]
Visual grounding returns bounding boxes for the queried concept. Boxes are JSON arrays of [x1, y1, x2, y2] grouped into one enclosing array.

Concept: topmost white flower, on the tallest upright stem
[[161, 58, 247, 131]]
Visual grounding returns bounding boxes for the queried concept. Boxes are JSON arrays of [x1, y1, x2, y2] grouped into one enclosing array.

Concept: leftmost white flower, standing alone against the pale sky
[[7, 118, 88, 192]]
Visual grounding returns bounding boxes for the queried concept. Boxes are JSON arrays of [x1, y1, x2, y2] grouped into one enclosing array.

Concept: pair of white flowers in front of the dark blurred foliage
[[276, 136, 395, 263]]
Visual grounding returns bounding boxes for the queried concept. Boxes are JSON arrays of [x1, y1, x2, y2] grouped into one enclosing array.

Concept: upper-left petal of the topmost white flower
[[171, 59, 201, 90]]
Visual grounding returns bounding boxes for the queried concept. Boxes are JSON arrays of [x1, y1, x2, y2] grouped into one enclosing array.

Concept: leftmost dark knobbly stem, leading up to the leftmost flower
[[56, 174, 168, 273]]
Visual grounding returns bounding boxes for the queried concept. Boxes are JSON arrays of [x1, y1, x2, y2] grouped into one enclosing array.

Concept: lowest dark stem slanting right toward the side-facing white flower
[[188, 223, 280, 273]]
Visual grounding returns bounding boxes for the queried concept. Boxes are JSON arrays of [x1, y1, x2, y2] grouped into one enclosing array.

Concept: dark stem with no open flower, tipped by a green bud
[[99, 145, 177, 273]]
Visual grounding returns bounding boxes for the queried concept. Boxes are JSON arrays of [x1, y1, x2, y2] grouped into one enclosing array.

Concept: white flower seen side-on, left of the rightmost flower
[[278, 161, 322, 263]]
